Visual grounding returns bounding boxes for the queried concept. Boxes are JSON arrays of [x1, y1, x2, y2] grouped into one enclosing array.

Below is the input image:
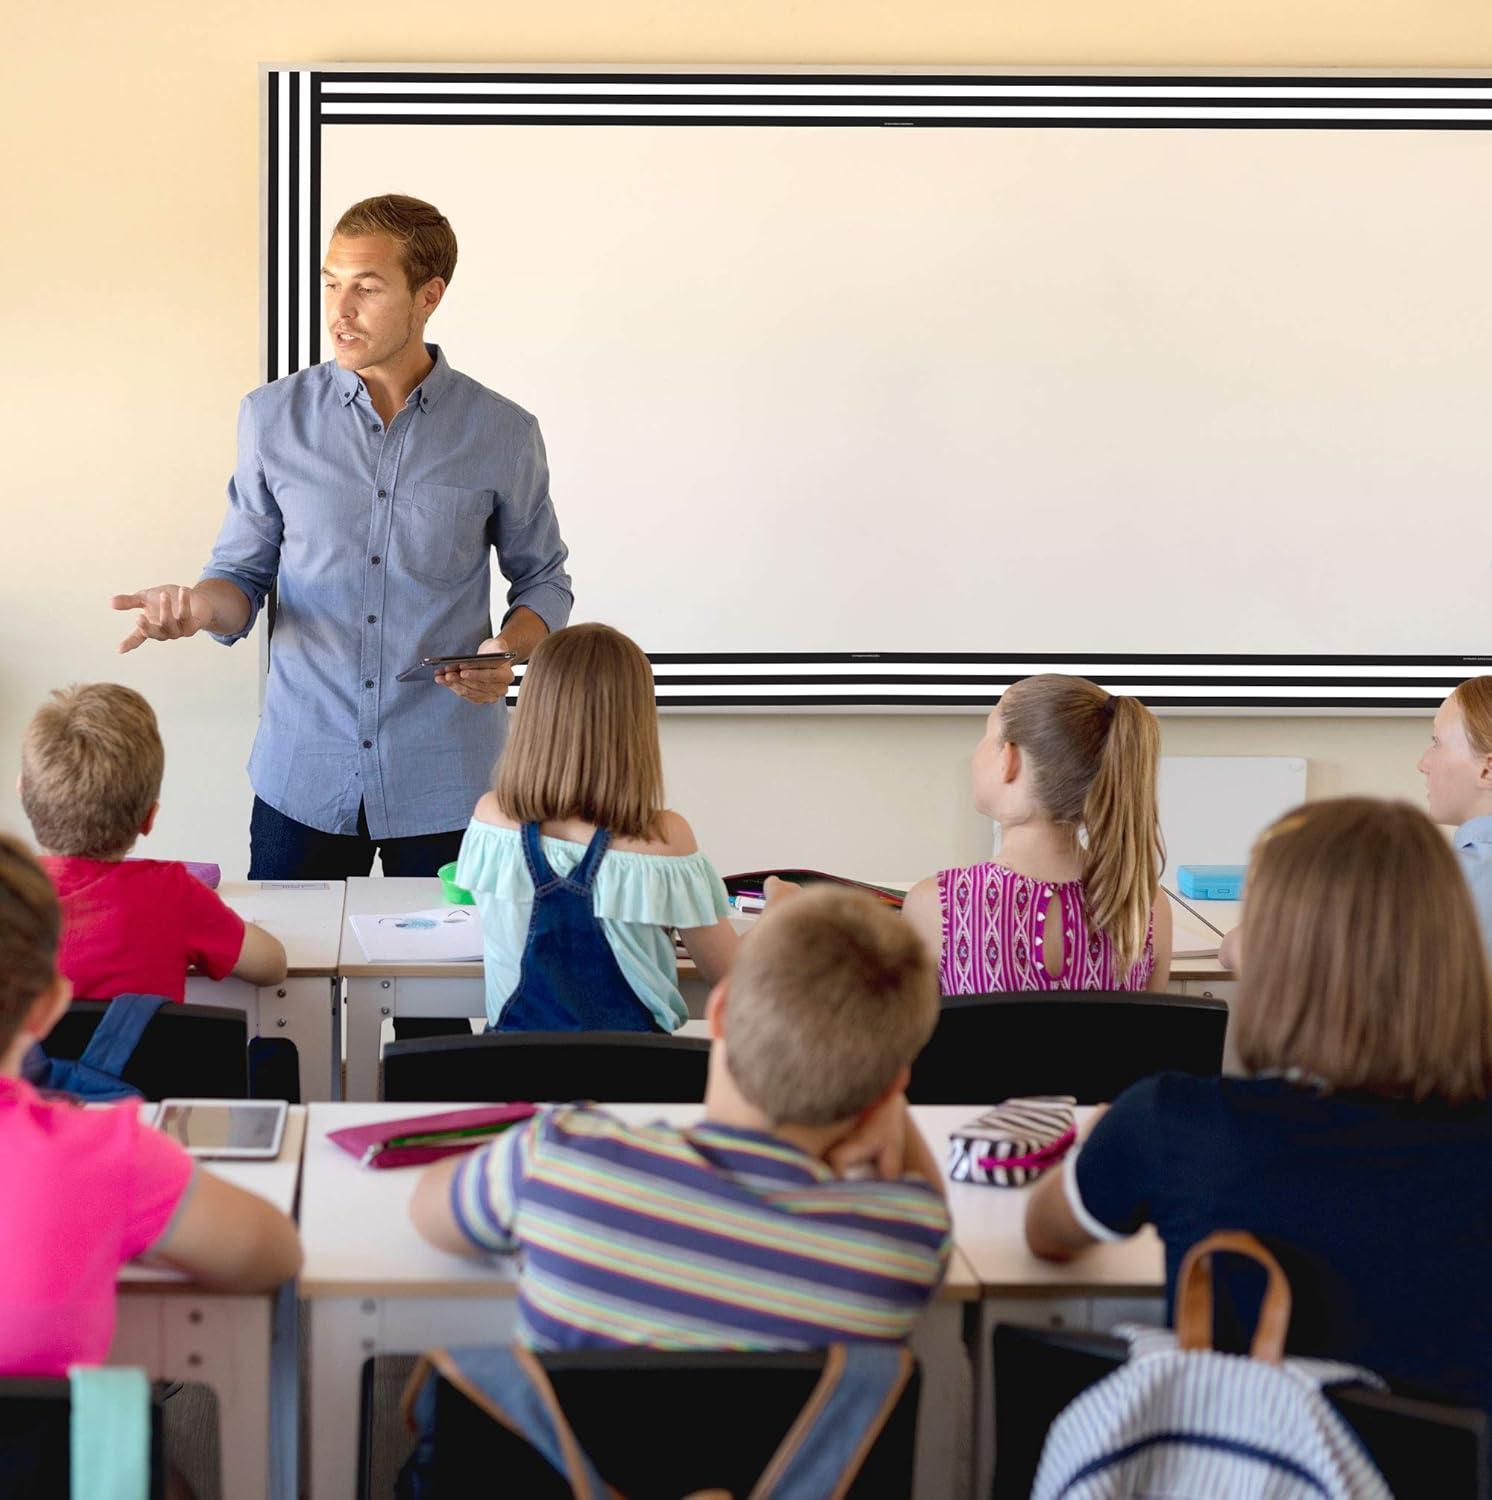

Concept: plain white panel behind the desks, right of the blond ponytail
[[1159, 755, 1306, 885]]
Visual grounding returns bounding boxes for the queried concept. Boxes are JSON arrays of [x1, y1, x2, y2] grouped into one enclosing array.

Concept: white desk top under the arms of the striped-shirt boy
[[300, 1104, 978, 1301]]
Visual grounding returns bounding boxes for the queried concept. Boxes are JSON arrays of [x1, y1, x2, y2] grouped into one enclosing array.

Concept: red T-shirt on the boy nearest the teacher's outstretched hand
[[42, 855, 243, 1001]]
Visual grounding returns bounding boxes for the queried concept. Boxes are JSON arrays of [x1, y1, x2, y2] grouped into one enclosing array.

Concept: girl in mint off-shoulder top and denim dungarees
[[456, 624, 736, 1032]]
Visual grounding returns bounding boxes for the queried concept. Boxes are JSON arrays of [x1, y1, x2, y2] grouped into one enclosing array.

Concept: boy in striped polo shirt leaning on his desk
[[411, 888, 949, 1350]]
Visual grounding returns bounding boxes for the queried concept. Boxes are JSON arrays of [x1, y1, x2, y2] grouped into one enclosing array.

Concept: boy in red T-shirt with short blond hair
[[18, 683, 285, 1002]]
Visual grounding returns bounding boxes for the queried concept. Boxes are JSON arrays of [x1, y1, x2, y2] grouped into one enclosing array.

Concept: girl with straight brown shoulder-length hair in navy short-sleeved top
[[1026, 798, 1492, 1410]]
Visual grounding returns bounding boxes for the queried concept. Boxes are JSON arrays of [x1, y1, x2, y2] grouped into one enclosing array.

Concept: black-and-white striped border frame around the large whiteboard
[[259, 63, 1492, 716]]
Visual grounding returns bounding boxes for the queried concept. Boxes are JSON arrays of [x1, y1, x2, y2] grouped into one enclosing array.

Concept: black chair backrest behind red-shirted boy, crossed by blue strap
[[42, 1001, 249, 1100]]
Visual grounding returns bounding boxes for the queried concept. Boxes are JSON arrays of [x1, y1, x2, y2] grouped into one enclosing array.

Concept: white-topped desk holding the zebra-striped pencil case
[[915, 1104, 1165, 1496]]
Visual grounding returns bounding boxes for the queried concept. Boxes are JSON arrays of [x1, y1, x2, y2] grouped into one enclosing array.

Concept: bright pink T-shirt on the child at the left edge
[[0, 1079, 192, 1377]]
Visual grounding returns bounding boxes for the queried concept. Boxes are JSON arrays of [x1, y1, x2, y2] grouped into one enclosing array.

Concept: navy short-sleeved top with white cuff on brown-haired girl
[[1065, 1073, 1492, 1412]]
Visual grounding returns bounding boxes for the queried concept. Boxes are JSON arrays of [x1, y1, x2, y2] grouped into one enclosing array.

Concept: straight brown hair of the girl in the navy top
[[1233, 797, 1492, 1103]]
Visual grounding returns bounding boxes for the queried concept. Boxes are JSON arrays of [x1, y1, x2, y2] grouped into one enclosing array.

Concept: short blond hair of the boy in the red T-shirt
[[21, 683, 166, 860]]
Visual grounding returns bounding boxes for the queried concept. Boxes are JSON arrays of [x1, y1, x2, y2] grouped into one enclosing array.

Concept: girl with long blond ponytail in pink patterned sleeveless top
[[903, 672, 1171, 995]]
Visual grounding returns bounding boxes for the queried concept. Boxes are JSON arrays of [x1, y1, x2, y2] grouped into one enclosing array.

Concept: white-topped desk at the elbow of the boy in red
[[186, 881, 346, 1103]]
